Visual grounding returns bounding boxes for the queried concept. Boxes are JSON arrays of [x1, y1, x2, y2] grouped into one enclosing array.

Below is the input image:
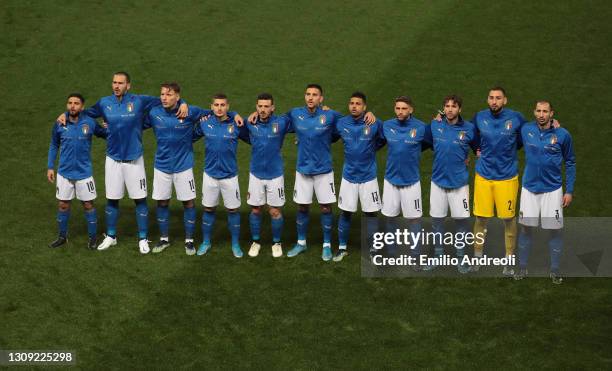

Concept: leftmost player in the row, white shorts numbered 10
[[47, 93, 108, 250]]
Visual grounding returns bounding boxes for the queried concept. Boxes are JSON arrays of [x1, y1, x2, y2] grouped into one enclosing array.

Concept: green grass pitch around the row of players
[[0, 0, 612, 369]]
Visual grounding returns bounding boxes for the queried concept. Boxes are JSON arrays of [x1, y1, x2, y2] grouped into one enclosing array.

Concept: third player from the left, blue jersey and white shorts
[[145, 82, 219, 255]]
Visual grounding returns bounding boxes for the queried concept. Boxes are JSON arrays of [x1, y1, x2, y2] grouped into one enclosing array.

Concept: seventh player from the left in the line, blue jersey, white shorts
[[334, 92, 383, 262]]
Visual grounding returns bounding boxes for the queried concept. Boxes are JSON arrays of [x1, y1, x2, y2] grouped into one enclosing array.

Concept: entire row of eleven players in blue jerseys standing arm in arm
[[47, 72, 576, 283]]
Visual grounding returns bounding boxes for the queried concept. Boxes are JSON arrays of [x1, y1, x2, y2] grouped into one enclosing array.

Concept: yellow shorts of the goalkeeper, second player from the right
[[474, 173, 518, 219]]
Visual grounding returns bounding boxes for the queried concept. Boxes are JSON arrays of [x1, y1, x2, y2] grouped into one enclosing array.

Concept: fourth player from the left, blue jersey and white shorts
[[194, 93, 248, 258]]
